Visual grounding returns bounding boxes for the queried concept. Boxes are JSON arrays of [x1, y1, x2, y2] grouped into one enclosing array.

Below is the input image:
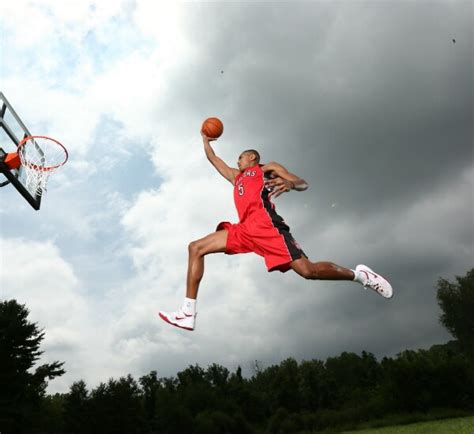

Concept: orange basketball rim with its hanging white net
[[17, 136, 68, 196]]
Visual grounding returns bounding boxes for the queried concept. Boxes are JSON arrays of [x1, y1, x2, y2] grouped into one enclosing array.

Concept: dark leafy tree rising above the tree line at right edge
[[437, 268, 474, 356]]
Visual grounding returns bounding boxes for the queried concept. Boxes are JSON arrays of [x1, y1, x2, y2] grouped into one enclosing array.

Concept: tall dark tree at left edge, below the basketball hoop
[[0, 300, 65, 434]]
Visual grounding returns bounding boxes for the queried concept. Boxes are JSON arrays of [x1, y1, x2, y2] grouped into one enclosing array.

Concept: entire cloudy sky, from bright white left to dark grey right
[[0, 0, 474, 392]]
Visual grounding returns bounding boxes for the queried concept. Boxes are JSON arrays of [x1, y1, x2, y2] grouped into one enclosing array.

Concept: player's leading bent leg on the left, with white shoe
[[159, 230, 228, 330]]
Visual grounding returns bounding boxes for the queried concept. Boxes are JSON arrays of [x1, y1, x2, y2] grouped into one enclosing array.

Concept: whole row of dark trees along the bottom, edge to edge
[[0, 269, 474, 434]]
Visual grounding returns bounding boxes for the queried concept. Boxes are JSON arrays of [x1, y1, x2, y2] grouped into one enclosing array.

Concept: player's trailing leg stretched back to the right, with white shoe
[[290, 256, 393, 298]]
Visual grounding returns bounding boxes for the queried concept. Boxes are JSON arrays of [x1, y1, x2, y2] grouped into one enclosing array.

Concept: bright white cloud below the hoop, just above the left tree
[[0, 238, 92, 390]]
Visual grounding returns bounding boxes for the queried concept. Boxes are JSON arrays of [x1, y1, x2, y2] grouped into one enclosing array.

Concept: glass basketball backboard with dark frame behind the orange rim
[[0, 92, 41, 210]]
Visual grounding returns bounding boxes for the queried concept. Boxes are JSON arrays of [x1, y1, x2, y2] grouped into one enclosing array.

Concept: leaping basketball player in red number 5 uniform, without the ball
[[159, 132, 392, 330]]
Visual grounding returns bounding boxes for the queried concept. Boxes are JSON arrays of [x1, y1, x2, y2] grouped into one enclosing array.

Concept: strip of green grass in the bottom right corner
[[344, 417, 474, 434]]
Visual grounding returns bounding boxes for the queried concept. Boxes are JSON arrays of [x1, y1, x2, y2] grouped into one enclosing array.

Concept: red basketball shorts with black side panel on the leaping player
[[216, 217, 306, 273]]
